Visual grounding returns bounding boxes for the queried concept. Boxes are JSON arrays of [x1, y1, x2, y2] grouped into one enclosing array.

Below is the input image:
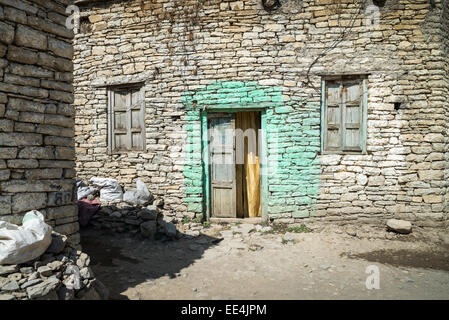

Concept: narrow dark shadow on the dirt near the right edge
[[342, 246, 449, 271]]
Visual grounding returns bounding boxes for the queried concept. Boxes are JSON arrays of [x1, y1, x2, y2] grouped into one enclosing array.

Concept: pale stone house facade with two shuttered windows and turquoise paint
[[73, 0, 449, 226]]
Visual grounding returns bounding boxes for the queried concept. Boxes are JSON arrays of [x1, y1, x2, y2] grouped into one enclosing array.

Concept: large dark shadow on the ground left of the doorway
[[80, 226, 220, 300]]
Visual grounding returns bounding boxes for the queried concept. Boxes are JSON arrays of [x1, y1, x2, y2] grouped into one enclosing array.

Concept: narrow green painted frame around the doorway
[[201, 108, 268, 221]]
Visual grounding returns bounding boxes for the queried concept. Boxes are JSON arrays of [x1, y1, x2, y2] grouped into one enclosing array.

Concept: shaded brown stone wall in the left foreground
[[0, 0, 79, 243]]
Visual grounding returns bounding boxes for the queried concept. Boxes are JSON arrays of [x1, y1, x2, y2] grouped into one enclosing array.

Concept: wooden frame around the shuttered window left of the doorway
[[107, 83, 146, 155]]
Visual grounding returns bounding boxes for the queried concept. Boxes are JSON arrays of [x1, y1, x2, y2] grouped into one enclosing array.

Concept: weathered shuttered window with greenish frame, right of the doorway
[[321, 76, 366, 154]]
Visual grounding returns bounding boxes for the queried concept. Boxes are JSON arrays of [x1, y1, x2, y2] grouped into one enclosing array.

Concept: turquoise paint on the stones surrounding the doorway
[[182, 81, 320, 218]]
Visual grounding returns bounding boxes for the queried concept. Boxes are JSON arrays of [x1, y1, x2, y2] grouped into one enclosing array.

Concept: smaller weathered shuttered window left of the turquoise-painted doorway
[[108, 87, 145, 153]]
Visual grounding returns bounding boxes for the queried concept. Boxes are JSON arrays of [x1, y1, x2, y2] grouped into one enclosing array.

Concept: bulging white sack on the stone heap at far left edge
[[0, 210, 52, 265]]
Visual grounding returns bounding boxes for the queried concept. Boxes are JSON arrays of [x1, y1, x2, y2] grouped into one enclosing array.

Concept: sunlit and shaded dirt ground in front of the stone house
[[81, 224, 449, 300]]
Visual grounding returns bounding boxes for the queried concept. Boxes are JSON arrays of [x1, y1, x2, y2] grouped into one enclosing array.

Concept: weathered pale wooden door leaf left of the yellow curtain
[[209, 113, 236, 218]]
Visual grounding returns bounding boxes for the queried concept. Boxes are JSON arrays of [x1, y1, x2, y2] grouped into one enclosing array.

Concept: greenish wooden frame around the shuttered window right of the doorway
[[320, 74, 368, 155]]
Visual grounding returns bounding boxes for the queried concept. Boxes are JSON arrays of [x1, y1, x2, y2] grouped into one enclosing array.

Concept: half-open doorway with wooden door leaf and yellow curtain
[[207, 111, 262, 218]]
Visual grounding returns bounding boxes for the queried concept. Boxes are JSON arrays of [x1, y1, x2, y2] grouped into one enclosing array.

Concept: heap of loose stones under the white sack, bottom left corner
[[0, 232, 109, 300]]
